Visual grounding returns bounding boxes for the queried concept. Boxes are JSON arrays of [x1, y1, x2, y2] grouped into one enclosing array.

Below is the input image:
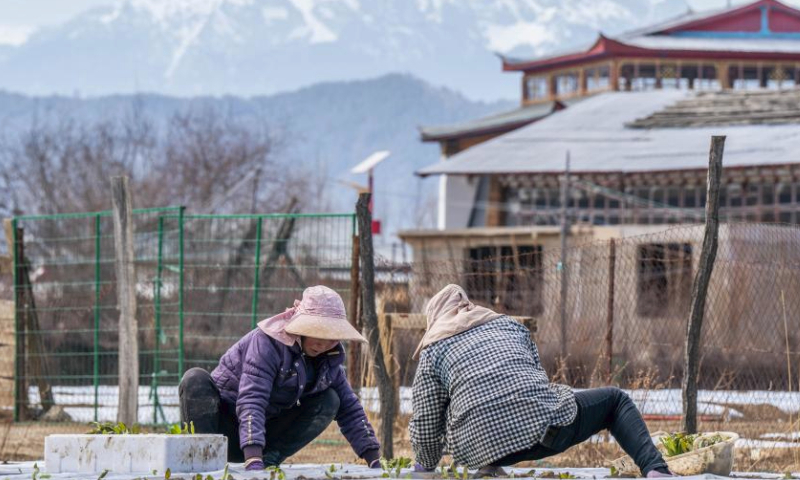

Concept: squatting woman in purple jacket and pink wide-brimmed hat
[[179, 286, 380, 470]]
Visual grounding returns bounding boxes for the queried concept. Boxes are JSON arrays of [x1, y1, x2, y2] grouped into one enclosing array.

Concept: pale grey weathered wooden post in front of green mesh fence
[[111, 177, 139, 425]]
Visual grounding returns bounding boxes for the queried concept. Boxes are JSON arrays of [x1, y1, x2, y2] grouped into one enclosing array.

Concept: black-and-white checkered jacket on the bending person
[[409, 317, 577, 468]]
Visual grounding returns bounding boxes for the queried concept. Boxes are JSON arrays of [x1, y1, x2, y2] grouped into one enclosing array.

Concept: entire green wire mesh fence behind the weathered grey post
[[12, 207, 355, 424]]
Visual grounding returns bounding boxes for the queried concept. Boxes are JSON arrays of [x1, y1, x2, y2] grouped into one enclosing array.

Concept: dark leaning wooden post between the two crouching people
[[356, 193, 395, 458]]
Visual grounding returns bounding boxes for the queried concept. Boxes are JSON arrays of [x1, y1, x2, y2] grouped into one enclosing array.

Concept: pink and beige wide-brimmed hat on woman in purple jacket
[[286, 285, 367, 343]]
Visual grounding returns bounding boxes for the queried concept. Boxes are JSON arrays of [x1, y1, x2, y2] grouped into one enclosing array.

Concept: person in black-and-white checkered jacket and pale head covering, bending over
[[409, 285, 672, 478]]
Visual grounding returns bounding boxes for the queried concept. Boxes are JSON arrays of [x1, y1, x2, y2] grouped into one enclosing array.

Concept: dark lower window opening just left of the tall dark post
[[636, 243, 692, 318]]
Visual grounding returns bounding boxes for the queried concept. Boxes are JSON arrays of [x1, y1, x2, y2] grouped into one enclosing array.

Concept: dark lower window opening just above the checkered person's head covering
[[463, 245, 544, 316]]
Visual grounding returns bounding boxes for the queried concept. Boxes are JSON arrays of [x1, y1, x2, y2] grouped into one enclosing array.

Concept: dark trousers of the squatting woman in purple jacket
[[178, 368, 339, 466]]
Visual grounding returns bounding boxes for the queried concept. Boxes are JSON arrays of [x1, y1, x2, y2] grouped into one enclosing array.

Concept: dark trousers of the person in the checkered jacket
[[494, 387, 667, 475]]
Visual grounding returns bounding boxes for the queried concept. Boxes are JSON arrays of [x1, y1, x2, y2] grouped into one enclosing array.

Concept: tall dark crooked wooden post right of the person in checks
[[682, 136, 725, 433]]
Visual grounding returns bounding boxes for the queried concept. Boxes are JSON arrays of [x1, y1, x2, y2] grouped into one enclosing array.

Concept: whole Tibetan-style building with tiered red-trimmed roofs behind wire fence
[[400, 0, 800, 378]]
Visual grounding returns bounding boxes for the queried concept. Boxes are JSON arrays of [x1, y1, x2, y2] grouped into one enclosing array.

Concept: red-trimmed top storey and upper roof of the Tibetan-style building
[[428, 0, 800, 156]]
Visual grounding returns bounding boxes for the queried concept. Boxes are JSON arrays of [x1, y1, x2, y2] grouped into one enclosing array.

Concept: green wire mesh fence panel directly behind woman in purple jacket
[[183, 214, 355, 376]]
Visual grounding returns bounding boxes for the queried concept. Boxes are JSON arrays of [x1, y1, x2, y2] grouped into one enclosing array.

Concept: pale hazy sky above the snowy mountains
[[0, 0, 800, 44]]
